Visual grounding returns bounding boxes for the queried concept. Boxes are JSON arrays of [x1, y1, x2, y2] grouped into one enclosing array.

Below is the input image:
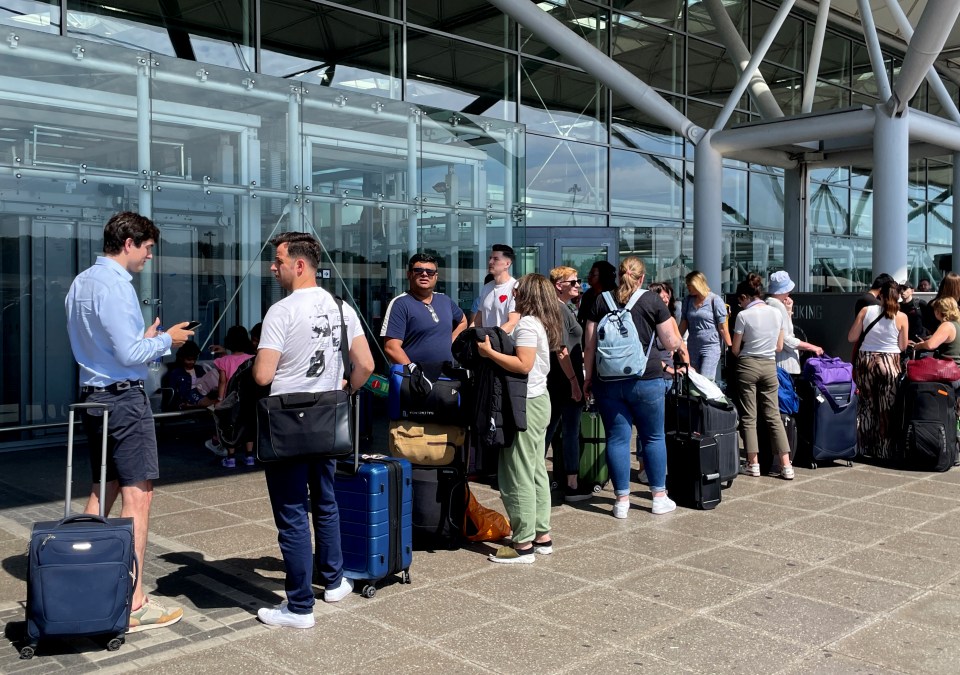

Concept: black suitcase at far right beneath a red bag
[[900, 380, 957, 471]]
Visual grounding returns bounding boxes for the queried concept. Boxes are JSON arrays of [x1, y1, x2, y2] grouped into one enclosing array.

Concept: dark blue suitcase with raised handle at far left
[[20, 403, 139, 659]]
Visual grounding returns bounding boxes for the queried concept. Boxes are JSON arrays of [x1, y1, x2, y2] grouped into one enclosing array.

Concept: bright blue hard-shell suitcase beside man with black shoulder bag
[[334, 455, 413, 598]]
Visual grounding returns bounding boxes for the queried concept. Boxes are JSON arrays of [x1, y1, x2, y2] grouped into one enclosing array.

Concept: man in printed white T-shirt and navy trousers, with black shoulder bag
[[253, 232, 373, 628]]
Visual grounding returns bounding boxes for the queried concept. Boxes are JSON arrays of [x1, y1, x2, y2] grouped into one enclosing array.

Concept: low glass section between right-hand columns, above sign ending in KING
[[810, 236, 873, 292]]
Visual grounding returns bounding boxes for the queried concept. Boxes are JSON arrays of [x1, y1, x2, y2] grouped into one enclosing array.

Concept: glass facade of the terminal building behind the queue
[[0, 0, 958, 447]]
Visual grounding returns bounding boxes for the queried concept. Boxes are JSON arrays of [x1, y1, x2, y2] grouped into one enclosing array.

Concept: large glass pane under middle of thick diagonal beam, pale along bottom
[[520, 59, 607, 142]]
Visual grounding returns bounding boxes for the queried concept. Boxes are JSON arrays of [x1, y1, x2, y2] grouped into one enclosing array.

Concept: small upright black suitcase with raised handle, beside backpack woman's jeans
[[666, 368, 721, 510]]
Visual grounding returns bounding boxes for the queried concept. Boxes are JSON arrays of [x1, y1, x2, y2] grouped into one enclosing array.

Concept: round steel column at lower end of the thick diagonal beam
[[693, 131, 723, 290]]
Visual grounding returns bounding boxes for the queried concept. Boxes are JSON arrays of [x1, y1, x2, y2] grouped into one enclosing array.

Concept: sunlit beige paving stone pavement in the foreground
[[0, 426, 960, 674]]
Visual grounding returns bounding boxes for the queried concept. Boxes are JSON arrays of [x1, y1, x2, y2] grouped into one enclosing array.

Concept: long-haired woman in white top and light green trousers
[[479, 274, 563, 564]]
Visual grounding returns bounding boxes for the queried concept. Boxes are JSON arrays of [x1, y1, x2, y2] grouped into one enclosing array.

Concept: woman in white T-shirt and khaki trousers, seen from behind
[[730, 274, 794, 480]]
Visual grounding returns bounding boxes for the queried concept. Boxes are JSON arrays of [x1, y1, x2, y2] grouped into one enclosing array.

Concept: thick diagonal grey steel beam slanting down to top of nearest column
[[489, 0, 704, 143]]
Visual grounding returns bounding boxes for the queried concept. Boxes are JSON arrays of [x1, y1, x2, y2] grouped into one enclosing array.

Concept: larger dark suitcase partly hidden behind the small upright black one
[[664, 376, 740, 487]]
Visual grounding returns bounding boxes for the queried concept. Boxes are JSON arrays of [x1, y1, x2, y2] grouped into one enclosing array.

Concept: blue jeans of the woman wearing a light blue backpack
[[593, 378, 667, 497]]
